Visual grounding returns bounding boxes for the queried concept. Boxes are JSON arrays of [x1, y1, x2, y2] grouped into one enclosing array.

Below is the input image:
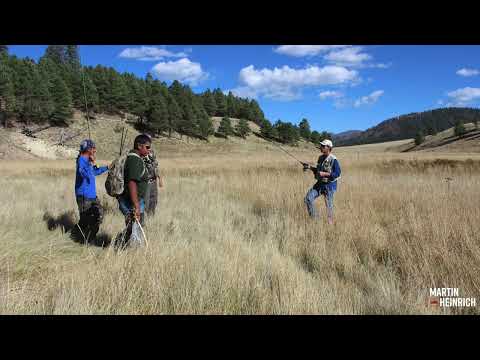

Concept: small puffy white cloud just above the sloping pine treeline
[[152, 58, 209, 86]]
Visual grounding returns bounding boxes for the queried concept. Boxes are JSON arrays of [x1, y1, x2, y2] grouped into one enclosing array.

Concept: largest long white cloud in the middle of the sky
[[232, 65, 358, 100]]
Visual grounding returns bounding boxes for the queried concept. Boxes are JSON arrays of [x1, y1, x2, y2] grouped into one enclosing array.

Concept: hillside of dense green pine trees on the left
[[0, 45, 331, 145]]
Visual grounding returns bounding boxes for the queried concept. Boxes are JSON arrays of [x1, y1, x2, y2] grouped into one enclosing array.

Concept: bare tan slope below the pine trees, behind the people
[[0, 112, 318, 160]]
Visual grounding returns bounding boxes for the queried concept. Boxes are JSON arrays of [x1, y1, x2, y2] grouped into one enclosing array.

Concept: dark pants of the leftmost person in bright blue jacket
[[72, 196, 103, 242]]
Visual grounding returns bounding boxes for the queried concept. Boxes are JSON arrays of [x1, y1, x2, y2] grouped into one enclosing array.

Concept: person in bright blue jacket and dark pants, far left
[[73, 139, 109, 242]]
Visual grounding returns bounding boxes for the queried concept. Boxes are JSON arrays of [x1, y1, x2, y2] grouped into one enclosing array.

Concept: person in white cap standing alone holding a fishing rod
[[303, 139, 341, 224]]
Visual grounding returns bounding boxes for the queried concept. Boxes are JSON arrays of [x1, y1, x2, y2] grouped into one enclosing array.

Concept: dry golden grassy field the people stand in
[[0, 144, 480, 314]]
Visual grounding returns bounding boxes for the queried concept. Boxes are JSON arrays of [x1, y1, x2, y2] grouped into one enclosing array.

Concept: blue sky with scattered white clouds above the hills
[[9, 45, 480, 133]]
